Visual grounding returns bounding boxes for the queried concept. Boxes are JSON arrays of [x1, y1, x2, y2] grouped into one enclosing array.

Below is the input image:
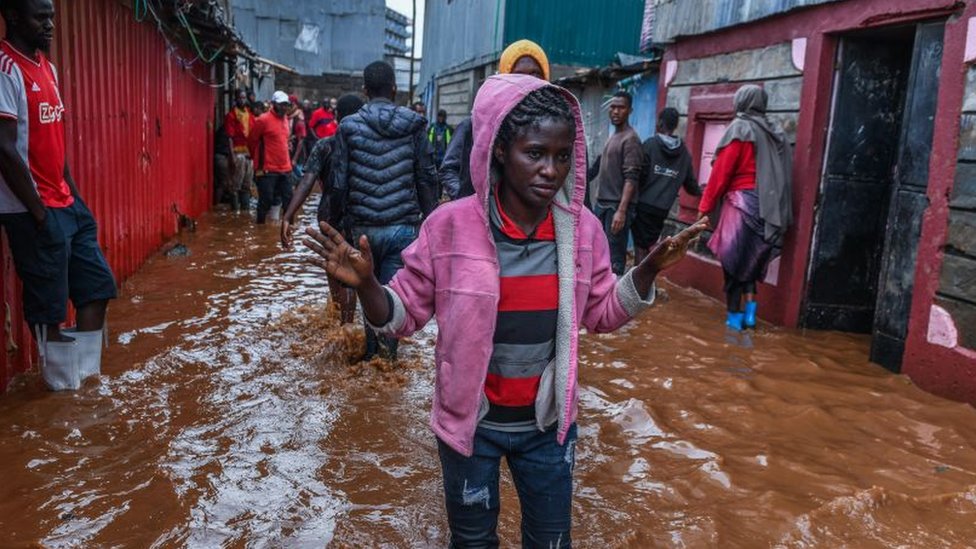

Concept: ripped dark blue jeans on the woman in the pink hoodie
[[437, 424, 576, 549]]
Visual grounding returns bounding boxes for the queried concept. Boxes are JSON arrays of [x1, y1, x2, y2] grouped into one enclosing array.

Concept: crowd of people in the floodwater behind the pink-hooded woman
[[223, 40, 792, 338]]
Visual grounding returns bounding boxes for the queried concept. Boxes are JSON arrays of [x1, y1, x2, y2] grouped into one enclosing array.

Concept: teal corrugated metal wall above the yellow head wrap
[[504, 0, 644, 67]]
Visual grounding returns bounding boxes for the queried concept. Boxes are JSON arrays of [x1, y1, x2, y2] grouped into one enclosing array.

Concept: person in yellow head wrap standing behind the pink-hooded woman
[[438, 40, 549, 200]]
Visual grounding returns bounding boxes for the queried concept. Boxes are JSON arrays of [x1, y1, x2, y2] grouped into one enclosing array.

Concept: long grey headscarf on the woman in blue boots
[[715, 84, 793, 246]]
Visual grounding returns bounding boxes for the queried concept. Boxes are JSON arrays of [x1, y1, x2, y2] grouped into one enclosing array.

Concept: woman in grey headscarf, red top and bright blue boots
[[698, 84, 793, 330]]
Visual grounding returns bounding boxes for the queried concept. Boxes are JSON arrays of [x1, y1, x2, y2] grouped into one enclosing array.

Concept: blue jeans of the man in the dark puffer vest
[[352, 225, 417, 360]]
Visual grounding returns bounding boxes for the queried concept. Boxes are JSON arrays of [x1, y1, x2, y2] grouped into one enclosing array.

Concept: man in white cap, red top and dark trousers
[[248, 91, 292, 225]]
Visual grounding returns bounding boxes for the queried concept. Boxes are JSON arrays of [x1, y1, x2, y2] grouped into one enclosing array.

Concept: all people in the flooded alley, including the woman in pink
[[0, 1, 792, 547]]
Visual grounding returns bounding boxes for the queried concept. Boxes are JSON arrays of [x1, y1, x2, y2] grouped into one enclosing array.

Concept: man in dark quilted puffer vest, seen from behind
[[332, 61, 438, 359]]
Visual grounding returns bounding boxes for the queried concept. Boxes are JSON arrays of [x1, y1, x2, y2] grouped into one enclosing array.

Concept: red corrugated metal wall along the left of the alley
[[0, 0, 215, 390]]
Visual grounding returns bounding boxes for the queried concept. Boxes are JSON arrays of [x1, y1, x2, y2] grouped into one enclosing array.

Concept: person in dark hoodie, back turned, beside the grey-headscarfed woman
[[631, 107, 701, 264]]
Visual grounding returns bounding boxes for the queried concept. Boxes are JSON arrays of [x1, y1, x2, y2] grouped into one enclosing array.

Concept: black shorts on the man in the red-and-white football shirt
[[0, 199, 117, 325]]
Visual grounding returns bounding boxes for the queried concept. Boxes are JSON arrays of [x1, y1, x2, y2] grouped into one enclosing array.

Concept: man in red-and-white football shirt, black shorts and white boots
[[0, 0, 116, 390]]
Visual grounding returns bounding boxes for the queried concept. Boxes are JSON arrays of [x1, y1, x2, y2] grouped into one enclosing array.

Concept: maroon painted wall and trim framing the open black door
[[658, 0, 976, 404]]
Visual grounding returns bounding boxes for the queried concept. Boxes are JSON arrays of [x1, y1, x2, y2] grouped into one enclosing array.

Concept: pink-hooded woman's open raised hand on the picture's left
[[303, 221, 379, 289]]
